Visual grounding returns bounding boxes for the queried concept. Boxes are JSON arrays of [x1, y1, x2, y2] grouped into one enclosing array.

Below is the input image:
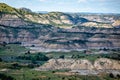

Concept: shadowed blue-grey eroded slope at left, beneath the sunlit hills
[[0, 23, 56, 43]]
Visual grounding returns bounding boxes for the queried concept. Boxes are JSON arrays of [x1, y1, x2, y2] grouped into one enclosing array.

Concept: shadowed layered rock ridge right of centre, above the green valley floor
[[23, 28, 120, 50]]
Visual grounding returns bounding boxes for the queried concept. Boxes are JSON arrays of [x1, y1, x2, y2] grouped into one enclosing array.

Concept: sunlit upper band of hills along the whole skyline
[[0, 3, 120, 28]]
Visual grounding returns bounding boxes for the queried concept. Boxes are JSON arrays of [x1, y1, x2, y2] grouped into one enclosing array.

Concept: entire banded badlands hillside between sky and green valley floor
[[0, 4, 120, 49]]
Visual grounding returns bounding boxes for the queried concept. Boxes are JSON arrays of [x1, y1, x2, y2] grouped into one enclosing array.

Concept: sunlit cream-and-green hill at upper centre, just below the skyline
[[25, 12, 74, 28]]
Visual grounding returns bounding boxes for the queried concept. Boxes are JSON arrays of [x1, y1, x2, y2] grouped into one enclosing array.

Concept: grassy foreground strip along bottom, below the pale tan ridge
[[0, 64, 119, 80]]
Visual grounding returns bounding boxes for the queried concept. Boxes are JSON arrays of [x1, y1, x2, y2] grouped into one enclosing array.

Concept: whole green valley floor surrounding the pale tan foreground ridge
[[0, 44, 120, 80]]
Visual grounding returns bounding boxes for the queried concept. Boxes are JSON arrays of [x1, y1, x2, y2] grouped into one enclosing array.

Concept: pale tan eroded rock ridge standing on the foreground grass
[[36, 58, 120, 70]]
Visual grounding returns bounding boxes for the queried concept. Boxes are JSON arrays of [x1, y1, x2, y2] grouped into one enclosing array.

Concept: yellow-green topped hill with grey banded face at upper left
[[0, 3, 27, 27]]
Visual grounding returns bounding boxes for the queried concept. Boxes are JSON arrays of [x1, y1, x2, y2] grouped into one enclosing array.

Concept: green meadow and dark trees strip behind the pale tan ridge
[[0, 43, 120, 62]]
